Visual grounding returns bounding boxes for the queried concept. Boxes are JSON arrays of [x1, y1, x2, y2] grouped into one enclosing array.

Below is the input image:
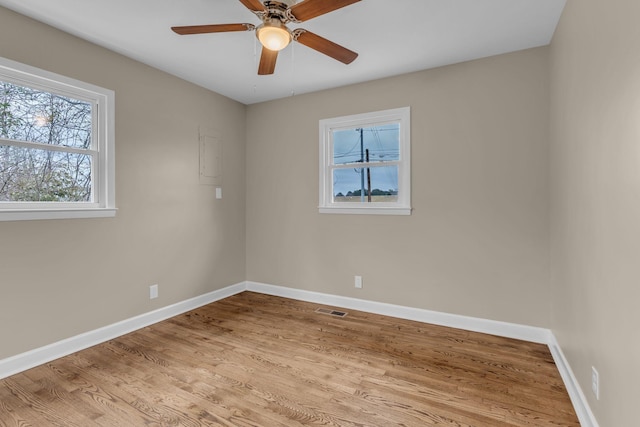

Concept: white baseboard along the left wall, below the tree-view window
[[0, 282, 246, 379]]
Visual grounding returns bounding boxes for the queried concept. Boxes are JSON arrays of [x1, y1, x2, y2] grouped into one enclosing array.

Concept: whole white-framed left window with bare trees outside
[[0, 58, 115, 221]]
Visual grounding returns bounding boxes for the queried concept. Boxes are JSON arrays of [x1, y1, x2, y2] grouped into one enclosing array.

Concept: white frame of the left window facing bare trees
[[0, 57, 116, 221]]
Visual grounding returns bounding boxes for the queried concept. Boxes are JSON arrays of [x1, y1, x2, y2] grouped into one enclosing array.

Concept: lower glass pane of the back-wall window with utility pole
[[333, 166, 398, 203]]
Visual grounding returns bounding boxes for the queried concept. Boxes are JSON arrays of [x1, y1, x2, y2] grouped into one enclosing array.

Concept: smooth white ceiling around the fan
[[0, 0, 565, 104]]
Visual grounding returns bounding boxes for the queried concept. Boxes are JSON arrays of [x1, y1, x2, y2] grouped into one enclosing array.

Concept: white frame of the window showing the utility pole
[[318, 107, 411, 215]]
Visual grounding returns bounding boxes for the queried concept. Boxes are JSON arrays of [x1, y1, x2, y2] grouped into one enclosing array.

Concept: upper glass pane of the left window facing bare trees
[[0, 81, 92, 149]]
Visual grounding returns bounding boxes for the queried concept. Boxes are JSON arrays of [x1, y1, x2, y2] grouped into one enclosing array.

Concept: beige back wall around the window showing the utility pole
[[247, 48, 550, 327]]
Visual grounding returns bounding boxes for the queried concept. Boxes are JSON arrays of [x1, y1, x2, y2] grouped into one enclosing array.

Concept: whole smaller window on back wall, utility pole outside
[[319, 107, 411, 215]]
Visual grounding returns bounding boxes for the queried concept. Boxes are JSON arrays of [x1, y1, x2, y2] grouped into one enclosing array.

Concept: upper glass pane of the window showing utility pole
[[332, 123, 400, 165]]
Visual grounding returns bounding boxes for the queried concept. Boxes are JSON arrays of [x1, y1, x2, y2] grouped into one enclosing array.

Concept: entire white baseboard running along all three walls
[[0, 282, 599, 427]]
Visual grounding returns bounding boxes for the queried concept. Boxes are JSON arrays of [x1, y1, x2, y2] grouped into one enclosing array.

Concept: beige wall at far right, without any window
[[550, 0, 640, 427]]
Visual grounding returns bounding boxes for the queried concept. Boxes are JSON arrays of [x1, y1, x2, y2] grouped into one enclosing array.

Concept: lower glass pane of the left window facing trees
[[0, 145, 92, 202]]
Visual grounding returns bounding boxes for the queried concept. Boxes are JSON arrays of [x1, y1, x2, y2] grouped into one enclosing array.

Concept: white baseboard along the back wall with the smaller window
[[247, 282, 551, 344]]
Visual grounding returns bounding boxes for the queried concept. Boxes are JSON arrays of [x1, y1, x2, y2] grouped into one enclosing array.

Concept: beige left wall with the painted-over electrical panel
[[0, 8, 245, 359]]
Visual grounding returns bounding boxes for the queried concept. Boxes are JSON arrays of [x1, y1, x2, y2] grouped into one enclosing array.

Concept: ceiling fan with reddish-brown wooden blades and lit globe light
[[171, 0, 360, 75]]
